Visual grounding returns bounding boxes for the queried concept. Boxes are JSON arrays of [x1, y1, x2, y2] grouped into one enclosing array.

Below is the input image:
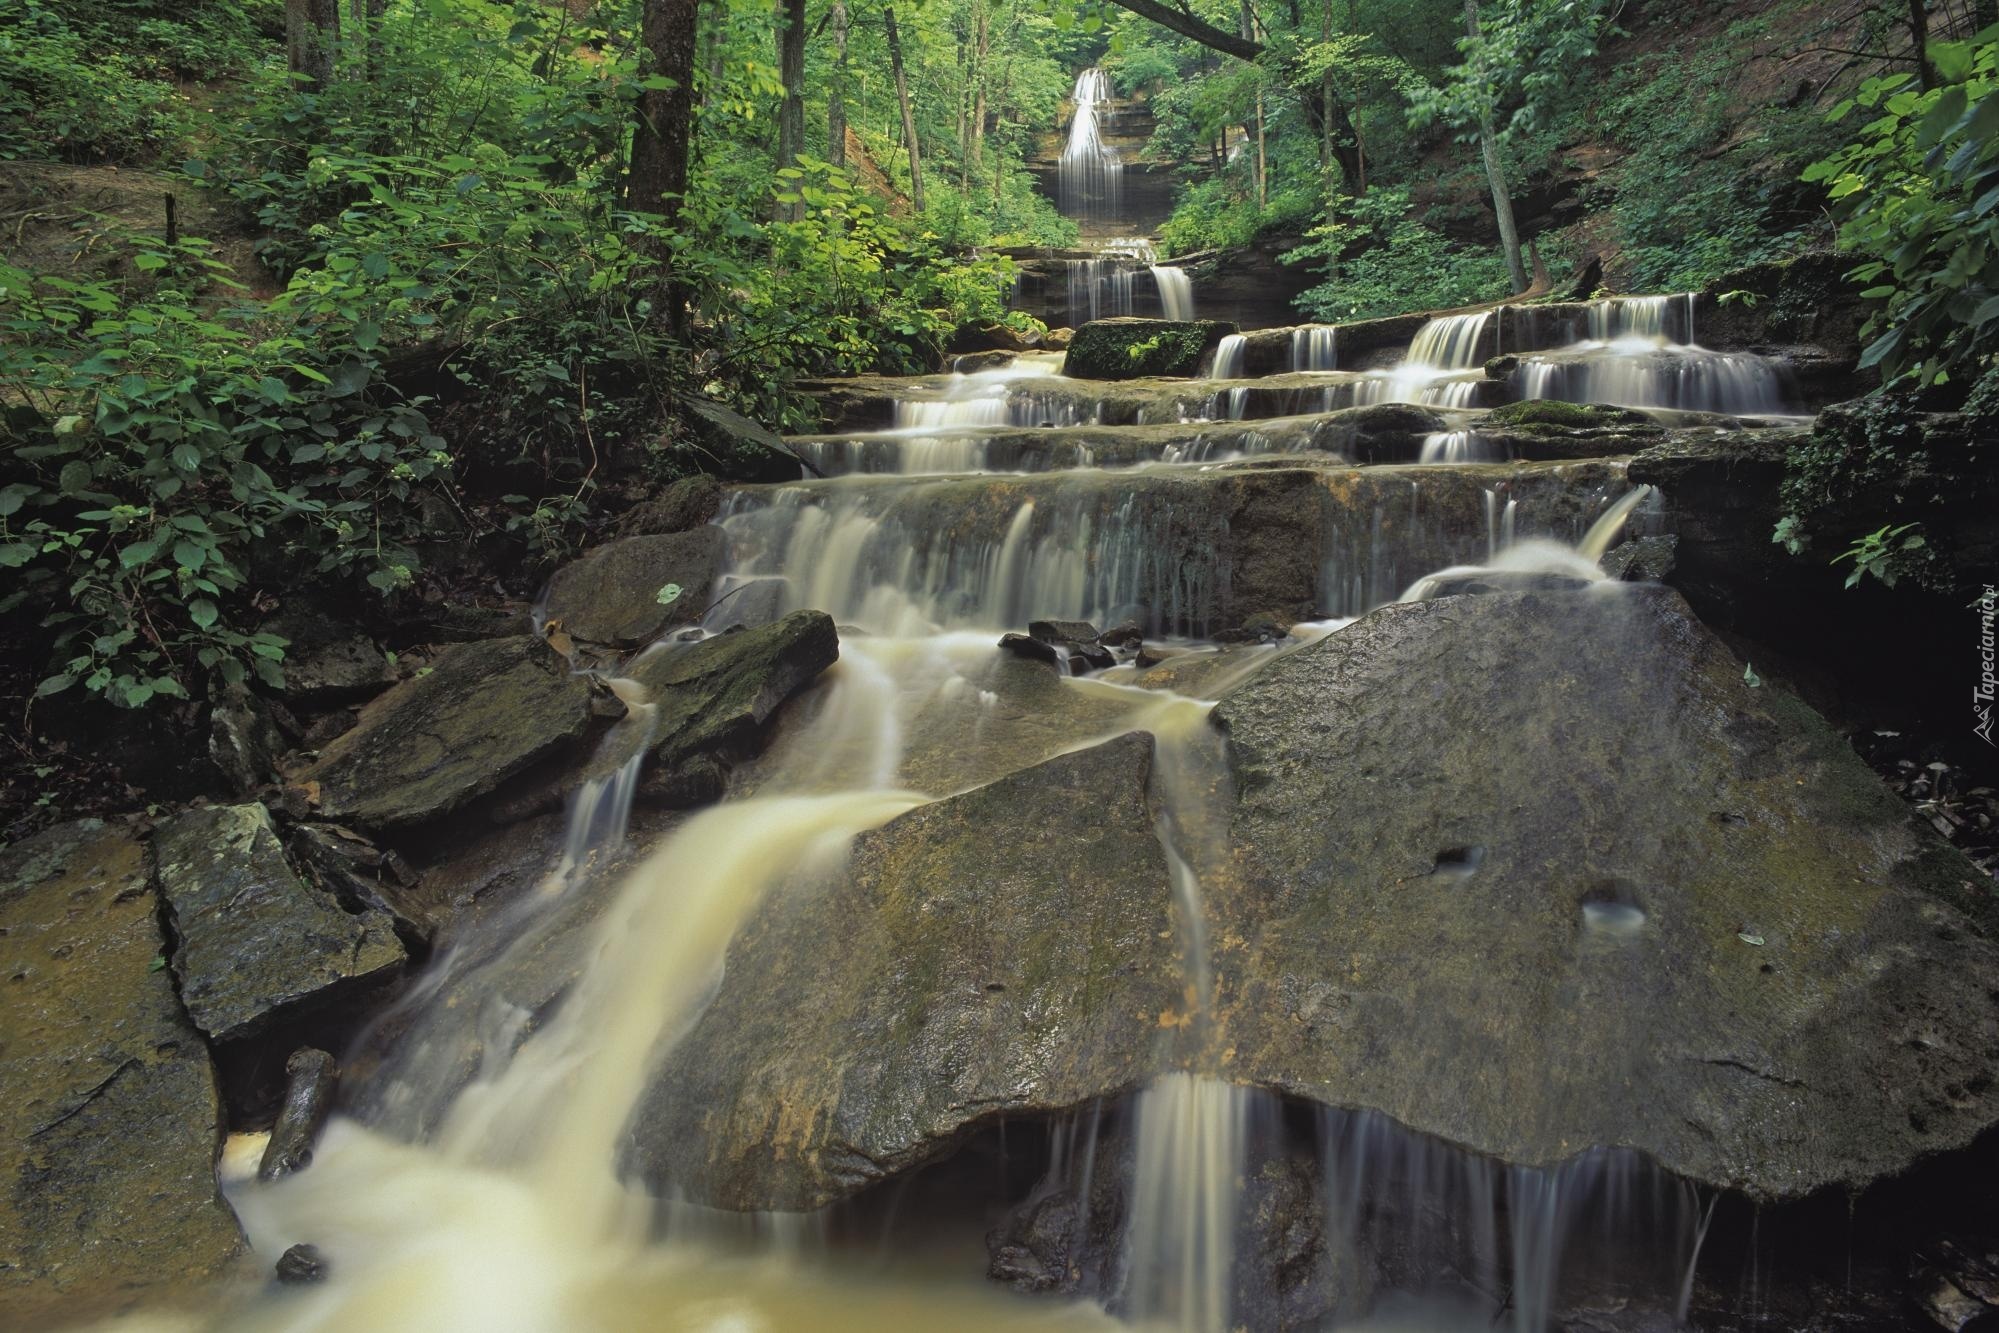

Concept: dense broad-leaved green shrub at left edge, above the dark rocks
[[0, 240, 450, 707]]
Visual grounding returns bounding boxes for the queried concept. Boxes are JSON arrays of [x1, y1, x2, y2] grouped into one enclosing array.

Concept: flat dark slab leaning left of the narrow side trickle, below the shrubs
[[300, 634, 590, 829]]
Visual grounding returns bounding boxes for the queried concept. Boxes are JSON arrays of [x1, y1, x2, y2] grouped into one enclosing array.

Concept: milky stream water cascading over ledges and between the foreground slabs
[[136, 283, 1799, 1333]]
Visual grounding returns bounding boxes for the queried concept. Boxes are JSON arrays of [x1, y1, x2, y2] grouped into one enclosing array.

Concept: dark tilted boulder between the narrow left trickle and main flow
[[626, 612, 840, 803]]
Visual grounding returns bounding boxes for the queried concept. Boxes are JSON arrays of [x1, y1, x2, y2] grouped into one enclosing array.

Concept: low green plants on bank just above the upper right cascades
[[1285, 190, 1509, 322]]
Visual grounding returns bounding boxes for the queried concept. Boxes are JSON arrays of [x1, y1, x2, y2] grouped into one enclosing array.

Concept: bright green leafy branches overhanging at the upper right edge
[[1805, 30, 1999, 384]]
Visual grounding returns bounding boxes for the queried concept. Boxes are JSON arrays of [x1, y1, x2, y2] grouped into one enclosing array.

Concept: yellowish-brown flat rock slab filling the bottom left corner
[[0, 819, 242, 1329]]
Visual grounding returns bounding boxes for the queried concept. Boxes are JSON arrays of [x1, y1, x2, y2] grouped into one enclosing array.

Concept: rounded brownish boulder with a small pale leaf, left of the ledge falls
[[546, 524, 722, 648]]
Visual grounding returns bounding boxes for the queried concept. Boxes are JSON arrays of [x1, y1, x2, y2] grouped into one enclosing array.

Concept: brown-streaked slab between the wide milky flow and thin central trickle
[[634, 733, 1181, 1209]]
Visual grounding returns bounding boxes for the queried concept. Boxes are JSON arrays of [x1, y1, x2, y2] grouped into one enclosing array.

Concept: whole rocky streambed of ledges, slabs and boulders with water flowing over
[[0, 287, 1999, 1331]]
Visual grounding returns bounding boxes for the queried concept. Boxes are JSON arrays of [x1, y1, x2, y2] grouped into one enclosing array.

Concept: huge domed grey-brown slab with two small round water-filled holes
[[1209, 586, 1999, 1197]]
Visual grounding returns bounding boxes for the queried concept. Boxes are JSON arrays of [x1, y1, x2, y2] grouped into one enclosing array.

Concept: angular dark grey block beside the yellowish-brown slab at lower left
[[152, 803, 406, 1041]]
